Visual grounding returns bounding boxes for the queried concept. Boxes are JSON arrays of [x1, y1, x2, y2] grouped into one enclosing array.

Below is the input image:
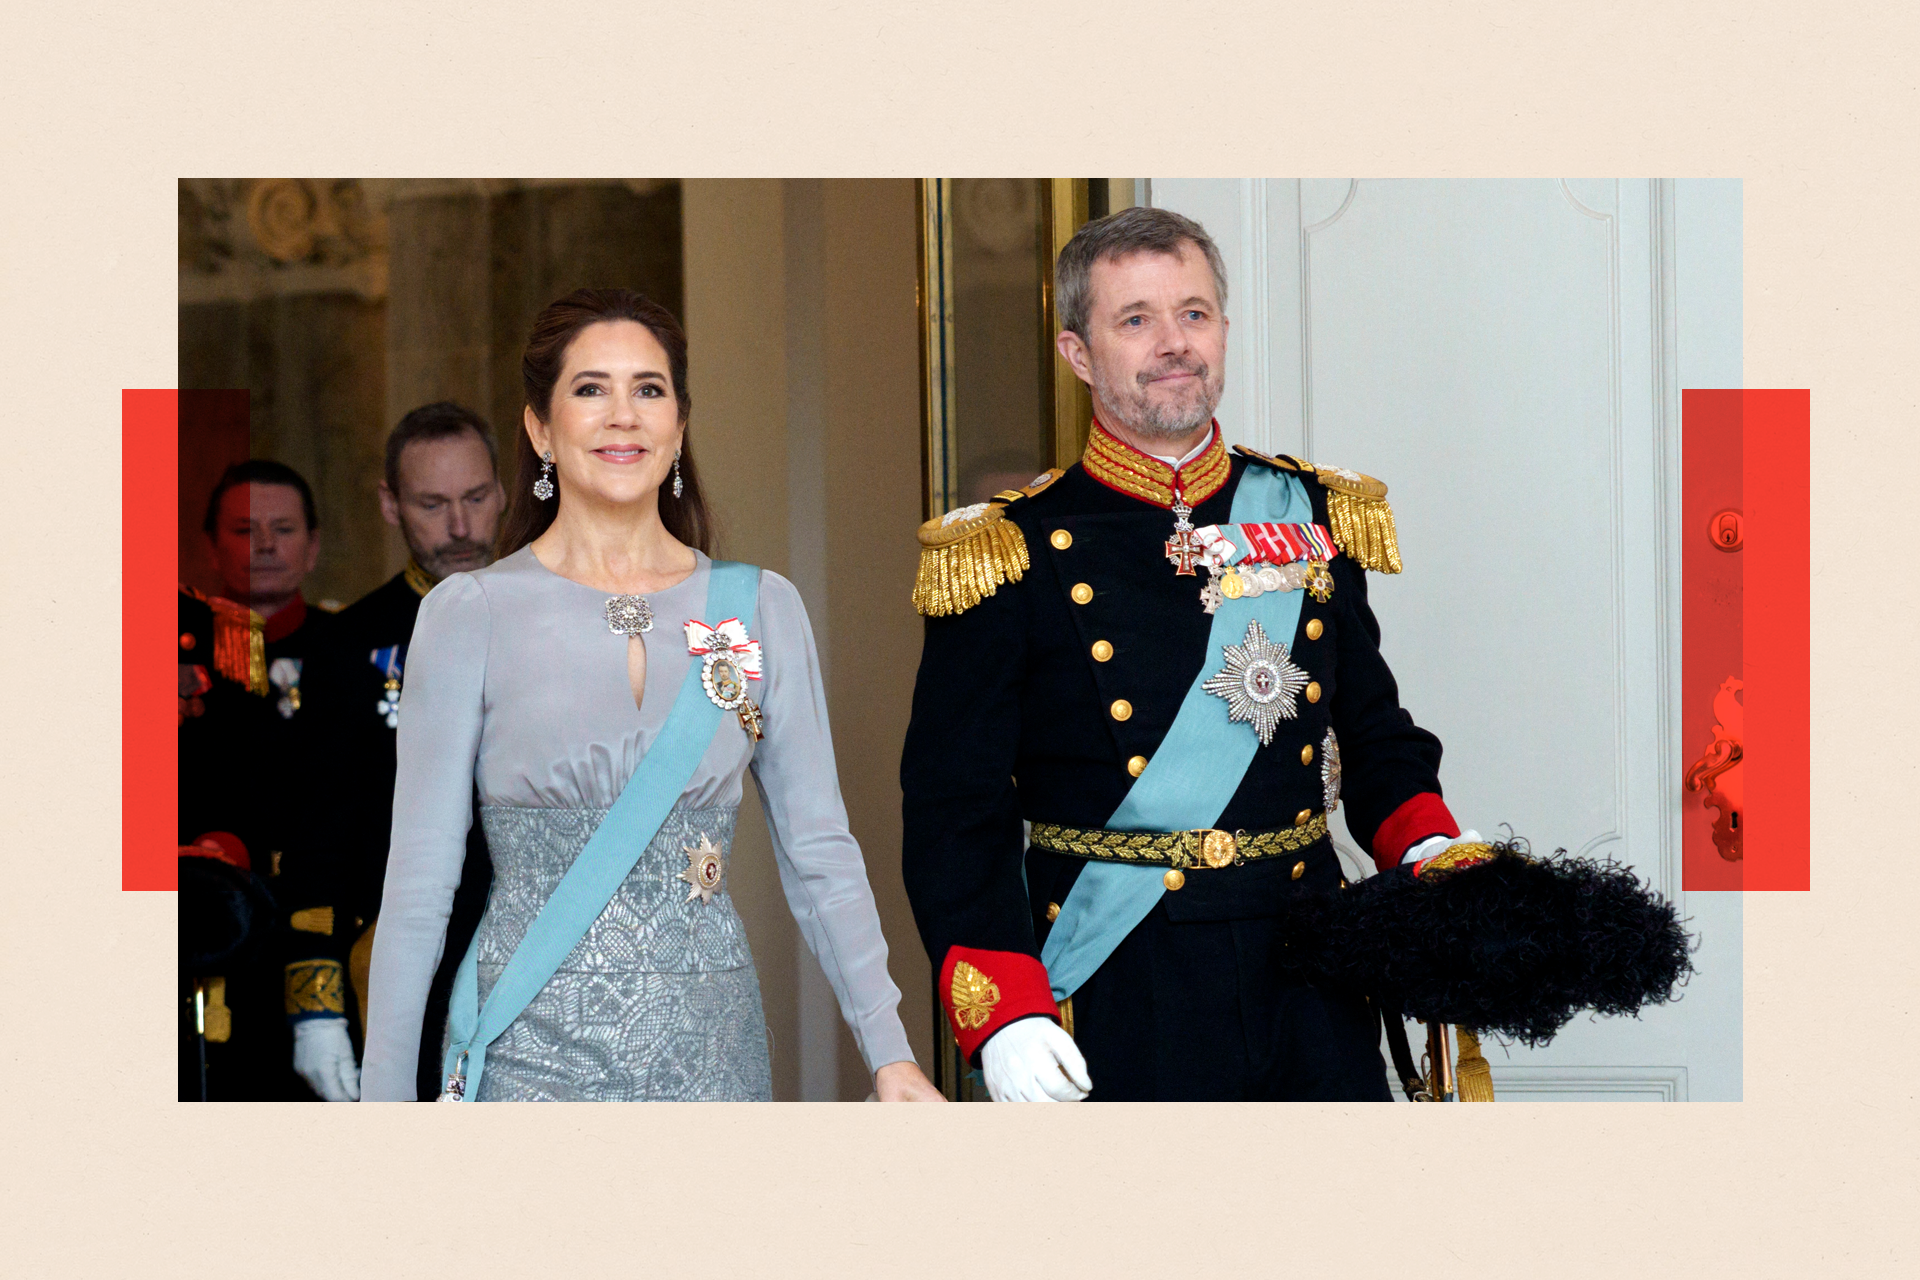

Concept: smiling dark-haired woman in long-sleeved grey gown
[[363, 290, 941, 1102]]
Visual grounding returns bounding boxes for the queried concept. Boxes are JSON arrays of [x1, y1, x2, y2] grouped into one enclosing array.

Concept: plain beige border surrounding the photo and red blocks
[[0, 0, 1920, 1276]]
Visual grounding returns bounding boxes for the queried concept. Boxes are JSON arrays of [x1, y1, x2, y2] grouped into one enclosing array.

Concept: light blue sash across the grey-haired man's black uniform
[[1041, 466, 1313, 1000]]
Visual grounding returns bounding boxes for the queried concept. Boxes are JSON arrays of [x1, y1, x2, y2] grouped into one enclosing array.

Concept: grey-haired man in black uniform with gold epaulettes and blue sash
[[900, 207, 1482, 1102]]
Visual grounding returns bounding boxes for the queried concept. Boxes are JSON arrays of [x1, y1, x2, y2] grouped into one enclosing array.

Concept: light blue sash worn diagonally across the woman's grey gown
[[444, 560, 760, 1100]]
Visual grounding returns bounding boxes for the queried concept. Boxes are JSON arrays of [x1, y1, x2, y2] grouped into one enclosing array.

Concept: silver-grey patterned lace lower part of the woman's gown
[[451, 806, 772, 1102]]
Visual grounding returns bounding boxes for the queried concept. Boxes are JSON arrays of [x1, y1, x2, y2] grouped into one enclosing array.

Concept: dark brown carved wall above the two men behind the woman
[[180, 178, 684, 603]]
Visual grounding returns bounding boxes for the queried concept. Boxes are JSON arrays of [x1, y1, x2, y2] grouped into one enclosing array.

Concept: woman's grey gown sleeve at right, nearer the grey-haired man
[[748, 572, 914, 1071]]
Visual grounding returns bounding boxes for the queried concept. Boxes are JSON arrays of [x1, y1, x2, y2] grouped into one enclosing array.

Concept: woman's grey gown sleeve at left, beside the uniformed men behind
[[361, 574, 492, 1102]]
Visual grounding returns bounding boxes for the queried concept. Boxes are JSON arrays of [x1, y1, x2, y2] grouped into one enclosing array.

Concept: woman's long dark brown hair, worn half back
[[499, 290, 712, 558]]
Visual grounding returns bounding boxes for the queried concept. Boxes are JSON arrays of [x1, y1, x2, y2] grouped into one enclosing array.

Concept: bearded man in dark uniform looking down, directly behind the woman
[[293, 401, 507, 1098]]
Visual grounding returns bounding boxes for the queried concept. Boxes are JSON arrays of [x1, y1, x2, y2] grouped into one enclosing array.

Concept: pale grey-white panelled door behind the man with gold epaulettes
[[1148, 178, 1741, 1102]]
